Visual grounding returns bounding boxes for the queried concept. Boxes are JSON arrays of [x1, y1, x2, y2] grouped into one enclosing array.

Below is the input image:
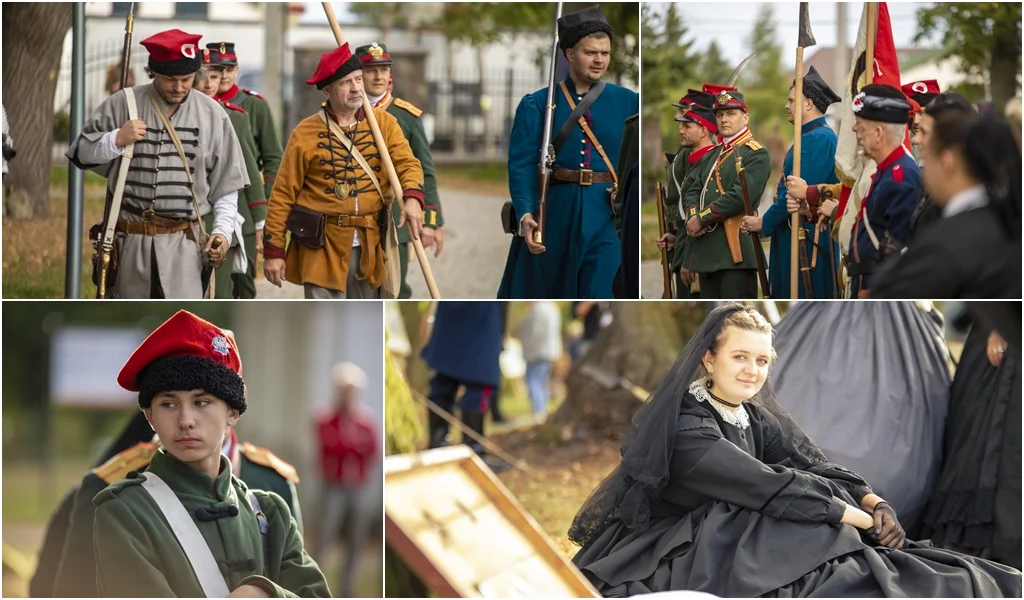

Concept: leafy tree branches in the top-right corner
[[914, 2, 1021, 107]]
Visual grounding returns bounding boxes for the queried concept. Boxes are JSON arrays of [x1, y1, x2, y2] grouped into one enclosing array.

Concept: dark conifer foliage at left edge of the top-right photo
[[640, 3, 701, 143]]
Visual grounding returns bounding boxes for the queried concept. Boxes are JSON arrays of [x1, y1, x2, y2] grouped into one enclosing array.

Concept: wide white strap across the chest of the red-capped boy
[[142, 472, 230, 598]]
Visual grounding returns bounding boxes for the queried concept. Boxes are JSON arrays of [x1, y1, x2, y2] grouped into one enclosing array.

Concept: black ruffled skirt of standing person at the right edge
[[920, 326, 1021, 568]]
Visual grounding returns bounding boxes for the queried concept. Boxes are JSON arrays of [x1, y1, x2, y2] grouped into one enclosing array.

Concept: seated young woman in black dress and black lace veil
[[569, 304, 1021, 598]]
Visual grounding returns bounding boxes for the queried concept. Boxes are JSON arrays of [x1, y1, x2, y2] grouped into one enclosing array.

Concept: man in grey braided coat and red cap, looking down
[[67, 30, 247, 298]]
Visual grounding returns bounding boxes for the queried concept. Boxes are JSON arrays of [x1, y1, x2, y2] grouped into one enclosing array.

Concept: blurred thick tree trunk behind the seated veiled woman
[[552, 302, 684, 439]]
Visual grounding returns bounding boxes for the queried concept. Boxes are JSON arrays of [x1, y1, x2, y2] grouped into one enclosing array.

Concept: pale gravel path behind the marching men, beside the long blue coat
[[250, 184, 511, 300]]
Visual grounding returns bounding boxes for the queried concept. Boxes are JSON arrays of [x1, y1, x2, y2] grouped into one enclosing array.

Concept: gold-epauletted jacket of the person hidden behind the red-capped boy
[[51, 436, 302, 598]]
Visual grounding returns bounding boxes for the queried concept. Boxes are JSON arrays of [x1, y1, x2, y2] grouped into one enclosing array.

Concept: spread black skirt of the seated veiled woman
[[572, 502, 1021, 598]]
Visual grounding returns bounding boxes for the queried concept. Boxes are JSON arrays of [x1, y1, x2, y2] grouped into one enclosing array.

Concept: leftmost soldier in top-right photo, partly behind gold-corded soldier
[[657, 89, 718, 300]]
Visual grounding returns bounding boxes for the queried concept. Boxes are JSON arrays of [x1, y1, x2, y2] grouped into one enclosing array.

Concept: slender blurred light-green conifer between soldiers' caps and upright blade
[[737, 4, 796, 137]]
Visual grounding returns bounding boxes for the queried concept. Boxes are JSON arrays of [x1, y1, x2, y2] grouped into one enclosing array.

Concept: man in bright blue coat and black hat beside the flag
[[740, 67, 842, 300]]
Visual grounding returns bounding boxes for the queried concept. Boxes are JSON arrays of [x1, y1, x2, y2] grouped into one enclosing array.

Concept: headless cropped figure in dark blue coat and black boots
[[422, 302, 508, 471]]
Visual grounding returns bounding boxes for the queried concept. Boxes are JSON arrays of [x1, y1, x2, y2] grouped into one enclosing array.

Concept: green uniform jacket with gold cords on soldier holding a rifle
[[683, 130, 771, 273]]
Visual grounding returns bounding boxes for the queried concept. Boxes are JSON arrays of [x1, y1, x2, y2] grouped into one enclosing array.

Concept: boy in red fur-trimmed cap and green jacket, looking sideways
[[93, 310, 330, 598]]
